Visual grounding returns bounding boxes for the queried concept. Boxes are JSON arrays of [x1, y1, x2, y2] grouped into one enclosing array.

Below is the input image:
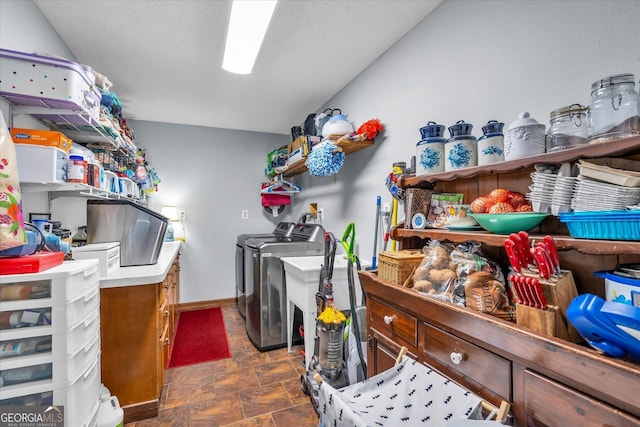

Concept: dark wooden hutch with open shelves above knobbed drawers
[[359, 137, 640, 426]]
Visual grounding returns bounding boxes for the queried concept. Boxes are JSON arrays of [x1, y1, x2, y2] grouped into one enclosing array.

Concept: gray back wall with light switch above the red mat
[[131, 121, 288, 302]]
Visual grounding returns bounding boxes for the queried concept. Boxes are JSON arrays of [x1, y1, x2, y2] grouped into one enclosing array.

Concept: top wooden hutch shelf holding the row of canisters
[[399, 136, 640, 188]]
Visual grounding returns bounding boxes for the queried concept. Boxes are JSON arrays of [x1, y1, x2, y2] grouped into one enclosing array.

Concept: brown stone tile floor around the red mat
[[125, 305, 318, 427]]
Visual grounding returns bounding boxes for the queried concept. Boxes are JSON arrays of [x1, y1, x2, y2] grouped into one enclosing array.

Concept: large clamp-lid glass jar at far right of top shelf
[[587, 74, 640, 143]]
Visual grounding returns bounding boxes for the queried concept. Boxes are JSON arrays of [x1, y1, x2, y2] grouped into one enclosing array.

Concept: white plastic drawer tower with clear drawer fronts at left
[[0, 260, 100, 406]]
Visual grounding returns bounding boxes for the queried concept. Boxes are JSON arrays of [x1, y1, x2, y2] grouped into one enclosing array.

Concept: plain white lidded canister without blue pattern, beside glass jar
[[504, 112, 546, 160]]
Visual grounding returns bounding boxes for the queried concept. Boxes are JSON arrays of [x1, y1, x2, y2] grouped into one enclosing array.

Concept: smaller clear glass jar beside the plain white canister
[[547, 104, 589, 152]]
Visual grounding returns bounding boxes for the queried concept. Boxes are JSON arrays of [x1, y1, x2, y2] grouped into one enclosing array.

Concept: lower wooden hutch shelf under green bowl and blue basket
[[391, 226, 640, 255]]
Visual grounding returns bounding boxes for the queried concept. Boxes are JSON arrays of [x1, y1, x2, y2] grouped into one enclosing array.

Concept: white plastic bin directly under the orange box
[[15, 144, 69, 184]]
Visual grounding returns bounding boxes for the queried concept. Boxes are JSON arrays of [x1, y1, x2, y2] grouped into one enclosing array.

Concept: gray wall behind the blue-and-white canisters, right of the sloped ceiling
[[295, 0, 640, 266]]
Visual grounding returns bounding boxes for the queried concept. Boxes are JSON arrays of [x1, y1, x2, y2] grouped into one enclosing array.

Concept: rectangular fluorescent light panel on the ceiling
[[222, 0, 277, 74]]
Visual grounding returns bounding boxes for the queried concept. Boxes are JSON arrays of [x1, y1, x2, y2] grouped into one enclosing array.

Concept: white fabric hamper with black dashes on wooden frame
[[318, 356, 482, 427]]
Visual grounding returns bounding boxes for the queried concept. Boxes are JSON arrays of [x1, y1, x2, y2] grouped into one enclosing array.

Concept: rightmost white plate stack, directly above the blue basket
[[571, 176, 640, 211]]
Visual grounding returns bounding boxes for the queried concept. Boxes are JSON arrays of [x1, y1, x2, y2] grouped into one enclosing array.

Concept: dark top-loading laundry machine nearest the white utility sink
[[245, 224, 325, 351]]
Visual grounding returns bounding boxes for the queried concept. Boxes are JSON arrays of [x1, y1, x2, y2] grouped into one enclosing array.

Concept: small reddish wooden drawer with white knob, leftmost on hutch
[[369, 298, 418, 348]]
